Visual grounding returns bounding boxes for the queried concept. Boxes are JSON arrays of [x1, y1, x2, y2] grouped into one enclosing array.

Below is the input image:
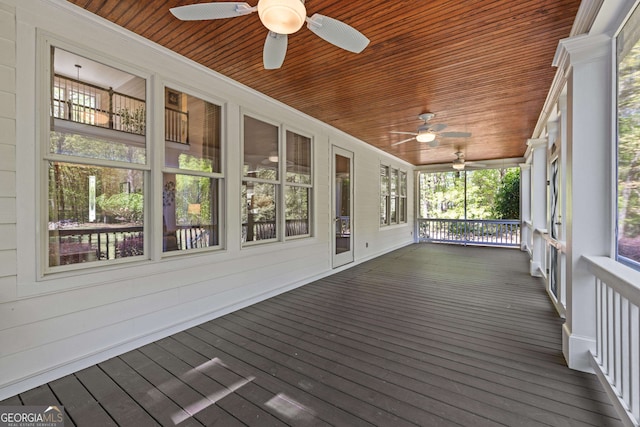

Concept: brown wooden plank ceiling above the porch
[[63, 0, 580, 165]]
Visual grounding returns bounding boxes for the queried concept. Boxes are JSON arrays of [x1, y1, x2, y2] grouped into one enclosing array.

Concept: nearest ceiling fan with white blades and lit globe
[[169, 0, 369, 70]]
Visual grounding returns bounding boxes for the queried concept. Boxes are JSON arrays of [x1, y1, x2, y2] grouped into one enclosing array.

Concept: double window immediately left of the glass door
[[241, 116, 313, 243]]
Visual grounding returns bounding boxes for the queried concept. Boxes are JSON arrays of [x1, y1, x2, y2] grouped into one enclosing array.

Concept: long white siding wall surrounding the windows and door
[[0, 0, 413, 399]]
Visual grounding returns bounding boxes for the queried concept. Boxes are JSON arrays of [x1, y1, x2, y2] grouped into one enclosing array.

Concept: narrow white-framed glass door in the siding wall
[[332, 146, 353, 268]]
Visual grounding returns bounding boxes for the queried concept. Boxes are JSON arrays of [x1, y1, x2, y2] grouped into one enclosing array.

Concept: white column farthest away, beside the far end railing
[[527, 139, 547, 276]]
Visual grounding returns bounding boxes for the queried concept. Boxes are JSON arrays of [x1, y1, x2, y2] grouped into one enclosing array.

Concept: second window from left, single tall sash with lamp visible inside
[[162, 88, 222, 252]]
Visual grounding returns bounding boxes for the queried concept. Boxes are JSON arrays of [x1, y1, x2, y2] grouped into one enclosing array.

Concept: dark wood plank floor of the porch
[[0, 244, 621, 427]]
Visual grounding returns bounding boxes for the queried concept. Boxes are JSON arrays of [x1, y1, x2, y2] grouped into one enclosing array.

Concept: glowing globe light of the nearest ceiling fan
[[258, 0, 307, 34]]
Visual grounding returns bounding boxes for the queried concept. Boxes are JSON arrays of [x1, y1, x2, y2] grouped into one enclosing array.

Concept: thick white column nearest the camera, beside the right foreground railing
[[556, 35, 615, 371]]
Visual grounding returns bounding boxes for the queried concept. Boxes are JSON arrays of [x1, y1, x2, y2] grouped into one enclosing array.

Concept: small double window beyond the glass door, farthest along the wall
[[380, 165, 407, 226]]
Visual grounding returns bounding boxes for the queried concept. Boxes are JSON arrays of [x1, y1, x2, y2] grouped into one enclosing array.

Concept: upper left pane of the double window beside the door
[[243, 116, 280, 180]]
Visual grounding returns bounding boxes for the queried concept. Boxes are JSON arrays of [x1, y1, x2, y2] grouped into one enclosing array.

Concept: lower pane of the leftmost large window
[[48, 162, 144, 267]]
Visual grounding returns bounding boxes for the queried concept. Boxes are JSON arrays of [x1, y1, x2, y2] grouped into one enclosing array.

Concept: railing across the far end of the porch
[[418, 218, 520, 247]]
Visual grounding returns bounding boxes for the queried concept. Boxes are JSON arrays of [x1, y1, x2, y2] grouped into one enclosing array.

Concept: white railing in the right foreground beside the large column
[[584, 256, 640, 426]]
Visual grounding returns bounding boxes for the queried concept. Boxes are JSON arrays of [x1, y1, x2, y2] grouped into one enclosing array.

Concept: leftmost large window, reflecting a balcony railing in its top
[[43, 47, 149, 269]]
